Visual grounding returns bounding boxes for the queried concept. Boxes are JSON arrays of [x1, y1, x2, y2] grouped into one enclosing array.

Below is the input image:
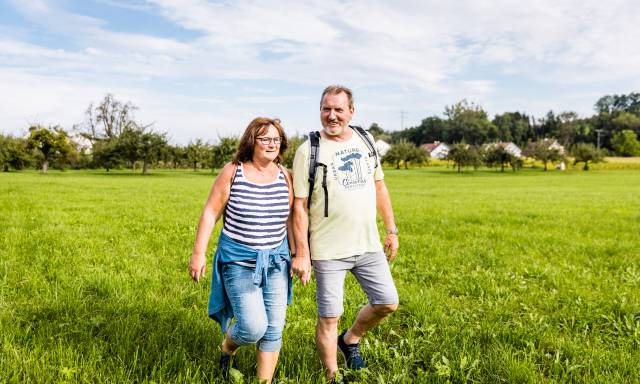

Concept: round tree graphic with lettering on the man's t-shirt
[[331, 147, 373, 191]]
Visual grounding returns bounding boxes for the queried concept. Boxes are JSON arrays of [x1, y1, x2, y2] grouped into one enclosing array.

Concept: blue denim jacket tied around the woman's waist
[[208, 233, 292, 333]]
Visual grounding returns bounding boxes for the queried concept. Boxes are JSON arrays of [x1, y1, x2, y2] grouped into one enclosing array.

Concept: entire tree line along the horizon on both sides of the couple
[[0, 93, 640, 174]]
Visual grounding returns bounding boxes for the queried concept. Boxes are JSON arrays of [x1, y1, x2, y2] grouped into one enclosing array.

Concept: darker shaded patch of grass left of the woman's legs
[[14, 299, 220, 382]]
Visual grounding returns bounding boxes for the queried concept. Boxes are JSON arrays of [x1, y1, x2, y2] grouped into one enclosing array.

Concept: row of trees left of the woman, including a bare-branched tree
[[0, 94, 248, 174]]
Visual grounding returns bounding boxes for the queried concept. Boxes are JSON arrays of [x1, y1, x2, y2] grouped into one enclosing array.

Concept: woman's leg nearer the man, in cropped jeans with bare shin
[[256, 261, 289, 383]]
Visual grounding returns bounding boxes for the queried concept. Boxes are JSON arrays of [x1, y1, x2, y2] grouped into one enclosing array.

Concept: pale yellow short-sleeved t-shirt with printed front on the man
[[293, 132, 384, 260]]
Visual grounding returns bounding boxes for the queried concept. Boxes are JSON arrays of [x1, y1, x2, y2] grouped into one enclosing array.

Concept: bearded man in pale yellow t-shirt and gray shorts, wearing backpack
[[292, 85, 398, 380]]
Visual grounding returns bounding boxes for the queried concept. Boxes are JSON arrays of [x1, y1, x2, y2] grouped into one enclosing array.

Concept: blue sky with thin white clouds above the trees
[[0, 0, 640, 145]]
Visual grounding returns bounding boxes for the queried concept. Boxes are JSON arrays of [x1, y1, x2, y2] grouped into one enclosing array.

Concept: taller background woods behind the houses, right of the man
[[384, 92, 640, 156]]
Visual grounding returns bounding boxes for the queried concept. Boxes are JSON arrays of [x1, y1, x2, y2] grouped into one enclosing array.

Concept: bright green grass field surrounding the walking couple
[[0, 167, 640, 383]]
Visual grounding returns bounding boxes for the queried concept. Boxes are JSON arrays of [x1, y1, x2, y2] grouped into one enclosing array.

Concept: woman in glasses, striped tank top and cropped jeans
[[189, 117, 295, 382]]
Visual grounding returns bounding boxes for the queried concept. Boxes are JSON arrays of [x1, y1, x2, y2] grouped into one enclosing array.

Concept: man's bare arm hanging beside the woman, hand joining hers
[[291, 197, 311, 286]]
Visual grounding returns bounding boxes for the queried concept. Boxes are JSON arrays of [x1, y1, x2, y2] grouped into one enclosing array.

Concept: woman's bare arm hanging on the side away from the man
[[189, 163, 237, 282]]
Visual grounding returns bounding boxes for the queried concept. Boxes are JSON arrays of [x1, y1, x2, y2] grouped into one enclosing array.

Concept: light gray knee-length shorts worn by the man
[[313, 252, 398, 317]]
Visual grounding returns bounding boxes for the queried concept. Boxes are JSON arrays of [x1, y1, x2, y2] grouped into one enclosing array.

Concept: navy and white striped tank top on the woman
[[222, 164, 289, 249]]
